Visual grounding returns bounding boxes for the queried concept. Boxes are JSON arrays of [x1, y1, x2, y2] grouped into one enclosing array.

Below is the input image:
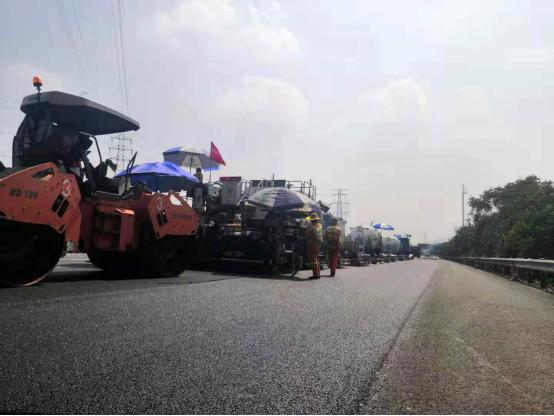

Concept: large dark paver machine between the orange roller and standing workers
[[195, 177, 315, 275]]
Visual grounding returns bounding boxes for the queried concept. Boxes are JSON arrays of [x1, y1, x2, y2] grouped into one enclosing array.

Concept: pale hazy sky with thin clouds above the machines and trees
[[0, 0, 554, 242]]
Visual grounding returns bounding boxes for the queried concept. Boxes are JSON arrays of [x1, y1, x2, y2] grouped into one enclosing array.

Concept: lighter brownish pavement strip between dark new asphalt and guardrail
[[360, 261, 554, 414]]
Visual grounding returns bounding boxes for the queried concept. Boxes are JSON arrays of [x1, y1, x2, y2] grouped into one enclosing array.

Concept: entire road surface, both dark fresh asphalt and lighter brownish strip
[[0, 256, 554, 413]]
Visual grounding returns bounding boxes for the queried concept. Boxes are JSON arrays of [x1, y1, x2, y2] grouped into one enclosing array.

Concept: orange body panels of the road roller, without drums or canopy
[[0, 163, 199, 252]]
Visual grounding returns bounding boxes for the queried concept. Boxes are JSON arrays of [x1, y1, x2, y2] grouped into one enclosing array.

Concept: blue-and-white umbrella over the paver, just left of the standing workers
[[248, 187, 320, 212]]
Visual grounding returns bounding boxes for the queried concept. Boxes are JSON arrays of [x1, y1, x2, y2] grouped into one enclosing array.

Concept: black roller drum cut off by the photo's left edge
[[0, 220, 65, 287]]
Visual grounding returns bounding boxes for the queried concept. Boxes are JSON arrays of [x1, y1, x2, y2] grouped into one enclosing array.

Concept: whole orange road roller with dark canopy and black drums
[[0, 78, 198, 286]]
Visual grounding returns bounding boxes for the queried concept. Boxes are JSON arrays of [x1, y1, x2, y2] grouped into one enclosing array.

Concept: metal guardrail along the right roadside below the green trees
[[447, 257, 554, 287]]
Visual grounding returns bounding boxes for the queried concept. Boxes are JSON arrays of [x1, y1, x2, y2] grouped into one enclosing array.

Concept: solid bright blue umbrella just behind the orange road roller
[[114, 161, 199, 192]]
